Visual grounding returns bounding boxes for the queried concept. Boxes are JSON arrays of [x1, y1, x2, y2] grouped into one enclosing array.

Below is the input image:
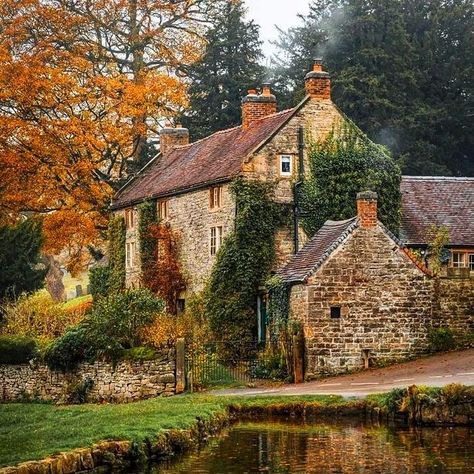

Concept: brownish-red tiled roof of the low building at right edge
[[400, 176, 474, 246]]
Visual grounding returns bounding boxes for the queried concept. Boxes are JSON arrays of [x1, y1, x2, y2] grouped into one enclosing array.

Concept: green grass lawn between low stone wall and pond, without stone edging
[[0, 394, 342, 466]]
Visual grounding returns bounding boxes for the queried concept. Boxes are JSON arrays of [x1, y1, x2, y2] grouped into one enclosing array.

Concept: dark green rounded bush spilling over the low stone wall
[[43, 325, 92, 372]]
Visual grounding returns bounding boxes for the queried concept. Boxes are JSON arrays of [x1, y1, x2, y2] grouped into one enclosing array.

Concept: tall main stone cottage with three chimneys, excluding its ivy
[[112, 60, 344, 307]]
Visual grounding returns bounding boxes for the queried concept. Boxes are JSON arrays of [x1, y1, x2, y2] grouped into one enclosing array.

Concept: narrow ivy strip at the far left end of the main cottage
[[108, 215, 125, 292]]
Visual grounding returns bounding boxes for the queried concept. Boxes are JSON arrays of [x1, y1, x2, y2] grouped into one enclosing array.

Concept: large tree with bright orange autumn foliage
[[0, 0, 211, 270]]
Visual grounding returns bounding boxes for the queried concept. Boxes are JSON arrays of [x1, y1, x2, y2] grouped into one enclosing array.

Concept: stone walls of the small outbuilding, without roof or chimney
[[291, 227, 433, 378]]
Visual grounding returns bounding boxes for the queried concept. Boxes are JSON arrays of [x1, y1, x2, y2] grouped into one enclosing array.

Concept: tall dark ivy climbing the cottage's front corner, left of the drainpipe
[[205, 178, 284, 361]]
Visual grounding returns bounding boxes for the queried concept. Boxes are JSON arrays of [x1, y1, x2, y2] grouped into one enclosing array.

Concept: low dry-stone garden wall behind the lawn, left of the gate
[[0, 348, 176, 403]]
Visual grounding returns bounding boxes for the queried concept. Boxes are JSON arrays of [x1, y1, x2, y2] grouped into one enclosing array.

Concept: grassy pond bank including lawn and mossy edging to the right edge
[[0, 384, 474, 467]]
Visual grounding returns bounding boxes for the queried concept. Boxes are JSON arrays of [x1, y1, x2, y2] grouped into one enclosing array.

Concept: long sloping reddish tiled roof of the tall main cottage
[[112, 109, 295, 208]]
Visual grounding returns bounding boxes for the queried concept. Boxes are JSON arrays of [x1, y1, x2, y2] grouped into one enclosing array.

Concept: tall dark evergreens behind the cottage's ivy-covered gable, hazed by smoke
[[273, 0, 474, 175]]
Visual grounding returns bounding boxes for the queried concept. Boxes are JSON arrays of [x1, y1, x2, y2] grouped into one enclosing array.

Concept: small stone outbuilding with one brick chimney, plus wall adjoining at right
[[278, 192, 474, 378]]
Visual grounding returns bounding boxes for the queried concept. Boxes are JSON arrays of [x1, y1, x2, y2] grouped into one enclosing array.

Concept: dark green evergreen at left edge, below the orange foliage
[[0, 219, 47, 300]]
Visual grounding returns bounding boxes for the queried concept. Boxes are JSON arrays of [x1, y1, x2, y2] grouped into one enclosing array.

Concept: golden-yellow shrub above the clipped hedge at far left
[[1, 290, 86, 344]]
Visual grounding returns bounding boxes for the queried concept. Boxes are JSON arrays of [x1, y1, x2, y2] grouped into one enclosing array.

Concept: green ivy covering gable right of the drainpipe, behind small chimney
[[299, 122, 401, 236]]
